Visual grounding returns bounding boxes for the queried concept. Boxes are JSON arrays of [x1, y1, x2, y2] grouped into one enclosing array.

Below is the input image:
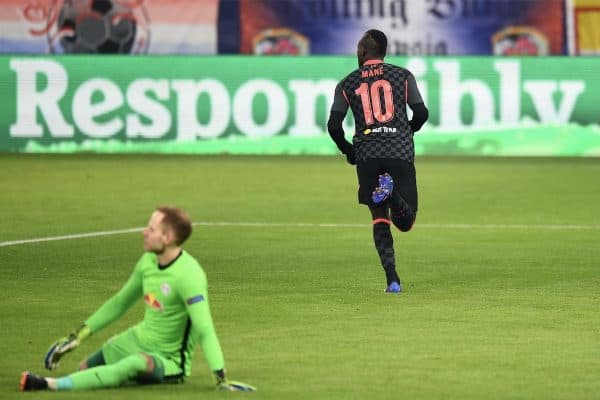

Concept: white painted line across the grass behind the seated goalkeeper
[[0, 222, 600, 247]]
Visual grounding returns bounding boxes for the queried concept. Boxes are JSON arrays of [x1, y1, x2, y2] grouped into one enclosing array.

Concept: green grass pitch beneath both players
[[0, 154, 600, 400]]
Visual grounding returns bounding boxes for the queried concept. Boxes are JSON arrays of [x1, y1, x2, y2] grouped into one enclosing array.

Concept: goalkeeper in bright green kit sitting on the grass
[[20, 207, 255, 391]]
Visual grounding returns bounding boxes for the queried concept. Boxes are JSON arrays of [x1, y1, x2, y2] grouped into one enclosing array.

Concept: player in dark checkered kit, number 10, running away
[[327, 29, 429, 293]]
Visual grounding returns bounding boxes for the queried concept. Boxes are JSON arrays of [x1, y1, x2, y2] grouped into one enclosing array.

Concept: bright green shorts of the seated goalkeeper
[[102, 328, 183, 383]]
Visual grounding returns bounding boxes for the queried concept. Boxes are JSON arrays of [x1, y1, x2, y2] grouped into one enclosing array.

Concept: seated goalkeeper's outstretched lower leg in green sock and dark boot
[[20, 353, 164, 391]]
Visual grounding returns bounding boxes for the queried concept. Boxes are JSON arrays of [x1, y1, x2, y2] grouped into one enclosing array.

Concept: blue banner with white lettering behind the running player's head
[[232, 0, 566, 55]]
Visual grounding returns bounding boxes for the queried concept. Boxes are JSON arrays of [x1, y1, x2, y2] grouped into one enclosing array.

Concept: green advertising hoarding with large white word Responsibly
[[0, 56, 600, 156]]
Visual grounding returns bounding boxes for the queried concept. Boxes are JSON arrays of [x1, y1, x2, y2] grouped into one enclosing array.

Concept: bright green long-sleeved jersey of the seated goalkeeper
[[85, 250, 224, 376]]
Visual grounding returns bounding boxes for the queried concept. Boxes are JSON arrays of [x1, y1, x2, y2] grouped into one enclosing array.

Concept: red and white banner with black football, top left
[[0, 0, 219, 54]]
